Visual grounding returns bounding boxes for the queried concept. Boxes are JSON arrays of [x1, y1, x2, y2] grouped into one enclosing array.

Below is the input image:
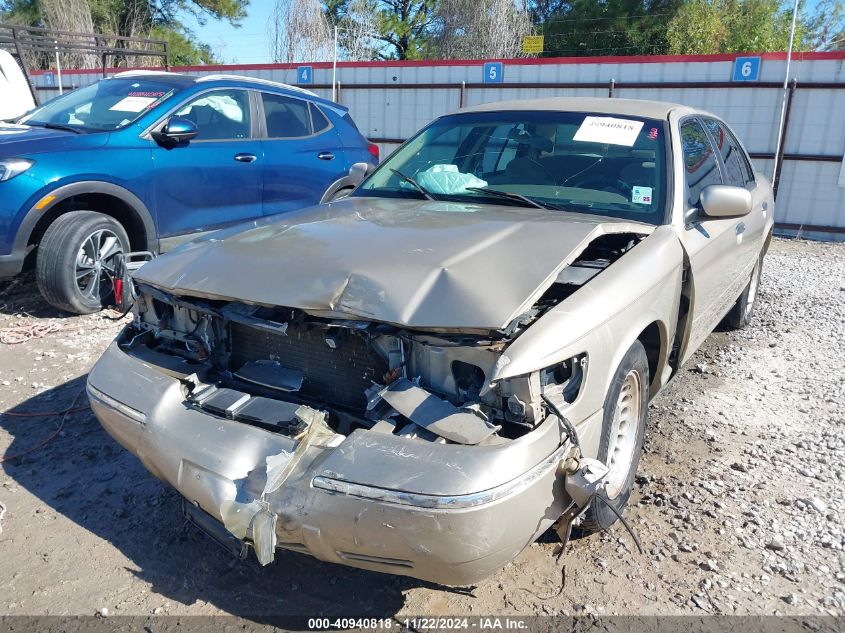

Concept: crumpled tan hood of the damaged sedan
[[135, 197, 654, 330]]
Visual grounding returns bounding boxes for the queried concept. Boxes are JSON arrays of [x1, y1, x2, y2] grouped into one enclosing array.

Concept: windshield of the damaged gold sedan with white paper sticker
[[355, 111, 666, 224]]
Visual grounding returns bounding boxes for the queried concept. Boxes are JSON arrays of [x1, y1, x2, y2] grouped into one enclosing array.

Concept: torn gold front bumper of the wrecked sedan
[[88, 343, 569, 585]]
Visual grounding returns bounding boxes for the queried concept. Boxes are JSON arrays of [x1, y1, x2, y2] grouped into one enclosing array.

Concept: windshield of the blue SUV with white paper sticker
[[20, 77, 179, 132]]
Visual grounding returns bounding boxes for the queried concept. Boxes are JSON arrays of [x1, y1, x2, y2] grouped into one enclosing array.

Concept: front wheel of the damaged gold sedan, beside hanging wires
[[579, 341, 650, 532]]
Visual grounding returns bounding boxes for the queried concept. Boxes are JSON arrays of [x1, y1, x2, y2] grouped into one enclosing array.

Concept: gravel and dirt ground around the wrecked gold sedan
[[0, 240, 845, 622]]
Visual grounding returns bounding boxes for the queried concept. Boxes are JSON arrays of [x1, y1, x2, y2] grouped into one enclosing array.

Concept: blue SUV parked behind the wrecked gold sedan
[[0, 72, 378, 314]]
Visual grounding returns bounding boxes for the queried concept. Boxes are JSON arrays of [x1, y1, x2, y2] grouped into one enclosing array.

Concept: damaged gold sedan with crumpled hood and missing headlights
[[88, 99, 773, 584]]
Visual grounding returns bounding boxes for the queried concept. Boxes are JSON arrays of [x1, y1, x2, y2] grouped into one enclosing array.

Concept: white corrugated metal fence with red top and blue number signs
[[24, 51, 845, 240]]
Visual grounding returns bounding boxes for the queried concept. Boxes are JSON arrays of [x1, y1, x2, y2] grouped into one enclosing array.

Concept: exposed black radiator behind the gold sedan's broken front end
[[230, 323, 388, 411]]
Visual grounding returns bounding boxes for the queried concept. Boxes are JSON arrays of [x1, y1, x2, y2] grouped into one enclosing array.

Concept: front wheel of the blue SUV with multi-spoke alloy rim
[[35, 211, 129, 314]]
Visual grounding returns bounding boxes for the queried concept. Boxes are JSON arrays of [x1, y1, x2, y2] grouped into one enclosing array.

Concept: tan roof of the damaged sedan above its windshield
[[460, 97, 694, 119]]
